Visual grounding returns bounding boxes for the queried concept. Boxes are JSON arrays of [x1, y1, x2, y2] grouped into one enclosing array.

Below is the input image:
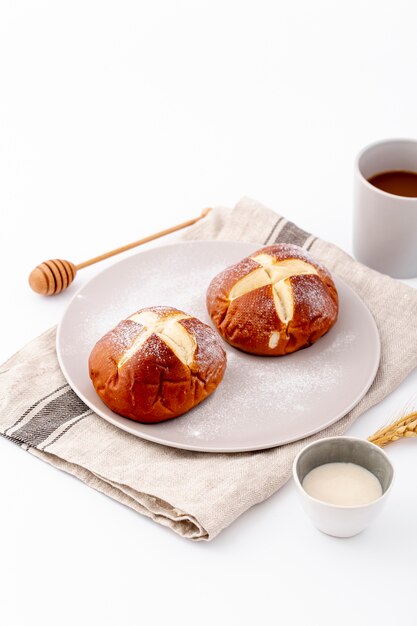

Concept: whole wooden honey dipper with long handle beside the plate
[[29, 209, 211, 296]]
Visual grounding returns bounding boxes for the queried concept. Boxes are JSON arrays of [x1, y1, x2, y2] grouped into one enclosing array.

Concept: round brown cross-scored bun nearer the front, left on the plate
[[89, 306, 226, 422]]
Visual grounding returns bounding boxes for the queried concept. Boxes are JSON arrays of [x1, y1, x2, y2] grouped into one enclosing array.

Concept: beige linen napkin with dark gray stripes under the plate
[[0, 199, 417, 540]]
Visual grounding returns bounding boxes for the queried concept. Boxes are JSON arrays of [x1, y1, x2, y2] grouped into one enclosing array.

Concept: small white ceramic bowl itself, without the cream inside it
[[293, 437, 394, 537]]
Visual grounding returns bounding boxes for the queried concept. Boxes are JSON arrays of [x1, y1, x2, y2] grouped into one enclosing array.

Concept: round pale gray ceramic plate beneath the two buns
[[57, 241, 380, 452]]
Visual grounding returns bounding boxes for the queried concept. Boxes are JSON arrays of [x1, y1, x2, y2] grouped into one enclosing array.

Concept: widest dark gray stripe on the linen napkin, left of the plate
[[13, 389, 88, 446]]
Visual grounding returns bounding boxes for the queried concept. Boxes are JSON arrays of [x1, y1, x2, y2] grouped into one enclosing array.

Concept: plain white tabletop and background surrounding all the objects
[[0, 0, 417, 626]]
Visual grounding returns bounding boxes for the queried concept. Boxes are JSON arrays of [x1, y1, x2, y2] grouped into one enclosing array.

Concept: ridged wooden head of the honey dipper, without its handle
[[29, 259, 77, 296]]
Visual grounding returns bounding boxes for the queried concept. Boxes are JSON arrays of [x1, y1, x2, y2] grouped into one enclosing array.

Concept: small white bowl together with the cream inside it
[[293, 437, 394, 537]]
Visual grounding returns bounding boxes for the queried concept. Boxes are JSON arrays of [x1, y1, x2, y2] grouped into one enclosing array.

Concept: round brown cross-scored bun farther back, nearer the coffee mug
[[207, 243, 338, 355]]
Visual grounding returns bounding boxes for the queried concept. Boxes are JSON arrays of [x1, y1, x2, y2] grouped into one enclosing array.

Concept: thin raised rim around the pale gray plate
[[55, 239, 381, 454]]
